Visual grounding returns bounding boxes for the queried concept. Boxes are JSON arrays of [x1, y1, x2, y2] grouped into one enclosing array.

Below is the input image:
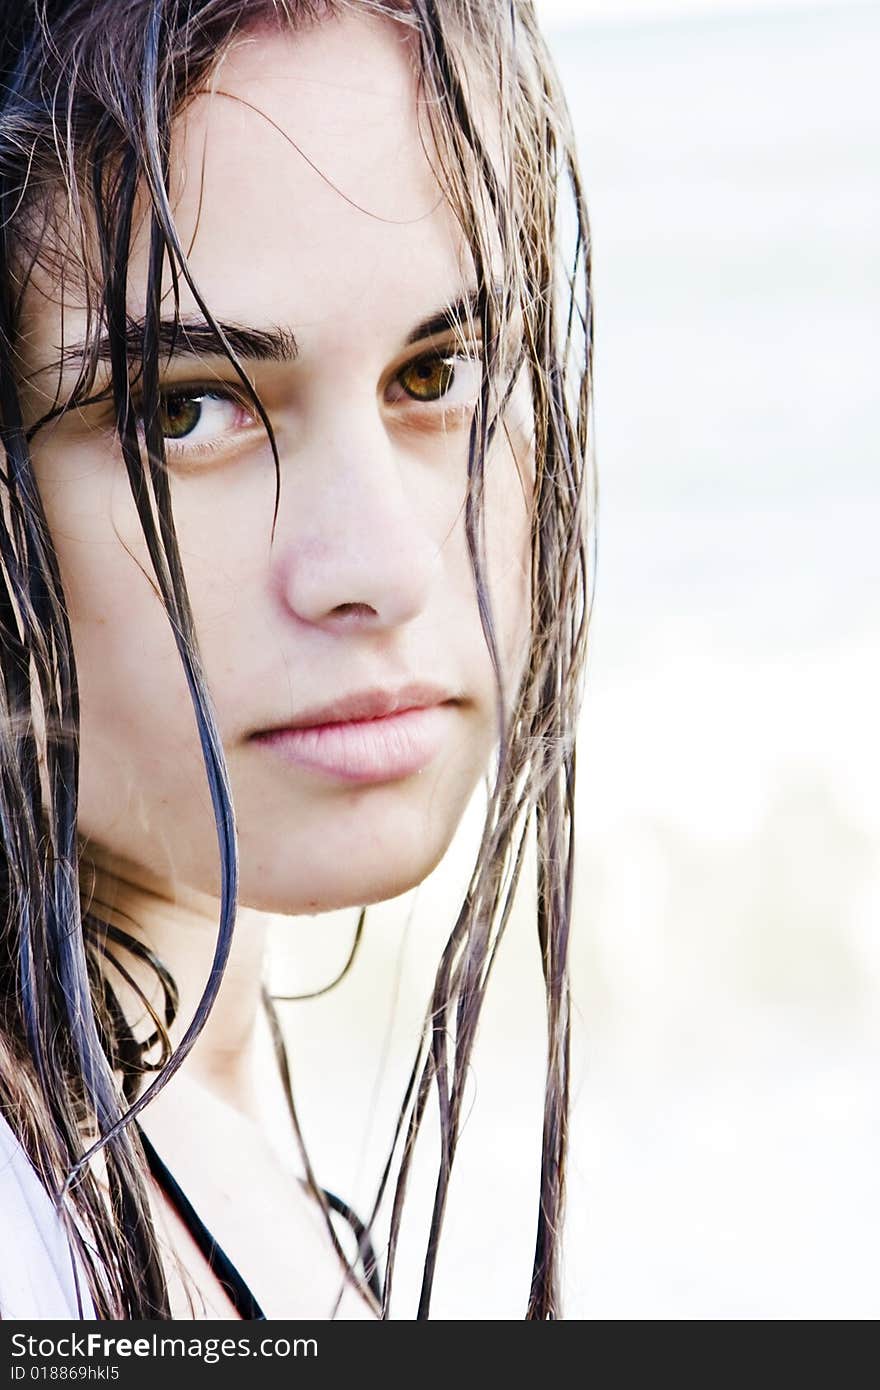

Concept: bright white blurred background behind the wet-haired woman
[[274, 0, 880, 1319]]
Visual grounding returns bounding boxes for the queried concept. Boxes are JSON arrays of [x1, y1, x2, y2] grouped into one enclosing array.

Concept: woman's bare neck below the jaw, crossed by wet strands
[[81, 848, 267, 1115]]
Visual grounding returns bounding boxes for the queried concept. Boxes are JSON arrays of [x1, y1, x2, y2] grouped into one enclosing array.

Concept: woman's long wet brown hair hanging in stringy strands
[[0, 0, 595, 1319]]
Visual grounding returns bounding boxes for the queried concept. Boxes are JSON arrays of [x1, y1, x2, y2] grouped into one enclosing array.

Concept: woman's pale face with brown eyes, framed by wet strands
[[18, 17, 531, 912]]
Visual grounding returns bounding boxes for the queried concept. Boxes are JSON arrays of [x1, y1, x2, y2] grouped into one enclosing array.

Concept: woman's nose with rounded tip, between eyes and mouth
[[271, 400, 441, 631]]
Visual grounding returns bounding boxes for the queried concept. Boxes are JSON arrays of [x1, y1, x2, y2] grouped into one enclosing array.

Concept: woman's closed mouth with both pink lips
[[253, 685, 462, 783]]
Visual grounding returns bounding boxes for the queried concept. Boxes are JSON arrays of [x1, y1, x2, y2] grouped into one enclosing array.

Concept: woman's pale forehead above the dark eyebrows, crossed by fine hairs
[[22, 15, 473, 383]]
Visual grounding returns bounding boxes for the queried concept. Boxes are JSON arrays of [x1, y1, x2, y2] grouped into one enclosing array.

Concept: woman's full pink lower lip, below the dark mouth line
[[248, 705, 449, 783]]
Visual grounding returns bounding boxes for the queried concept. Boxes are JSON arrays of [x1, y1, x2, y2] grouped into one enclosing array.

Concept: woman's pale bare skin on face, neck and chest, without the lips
[[18, 15, 530, 1318]]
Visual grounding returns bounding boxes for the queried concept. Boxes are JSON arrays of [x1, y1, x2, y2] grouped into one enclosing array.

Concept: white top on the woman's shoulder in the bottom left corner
[[0, 1115, 96, 1319]]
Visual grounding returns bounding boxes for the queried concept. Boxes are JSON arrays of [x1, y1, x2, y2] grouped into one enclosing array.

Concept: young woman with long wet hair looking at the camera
[[0, 0, 592, 1319]]
